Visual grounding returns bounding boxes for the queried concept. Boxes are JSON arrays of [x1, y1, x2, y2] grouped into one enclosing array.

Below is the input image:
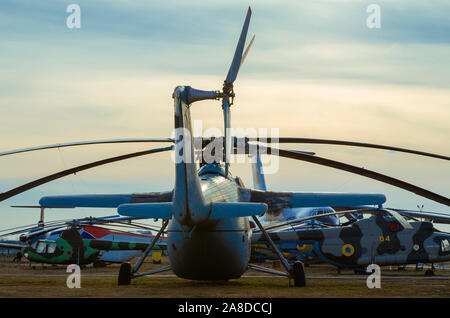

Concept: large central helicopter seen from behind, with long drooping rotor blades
[[0, 8, 450, 287]]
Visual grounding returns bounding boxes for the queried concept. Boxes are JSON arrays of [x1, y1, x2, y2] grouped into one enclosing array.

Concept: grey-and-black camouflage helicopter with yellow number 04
[[252, 209, 450, 276]]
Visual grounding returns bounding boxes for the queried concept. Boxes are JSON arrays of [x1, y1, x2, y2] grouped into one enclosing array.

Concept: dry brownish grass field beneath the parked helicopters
[[0, 257, 450, 298]]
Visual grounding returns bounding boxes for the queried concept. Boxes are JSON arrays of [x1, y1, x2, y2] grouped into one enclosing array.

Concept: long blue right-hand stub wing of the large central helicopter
[[240, 189, 386, 210]]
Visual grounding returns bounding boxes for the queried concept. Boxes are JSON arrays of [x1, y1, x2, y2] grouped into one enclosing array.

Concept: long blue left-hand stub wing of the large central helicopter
[[39, 191, 173, 208]]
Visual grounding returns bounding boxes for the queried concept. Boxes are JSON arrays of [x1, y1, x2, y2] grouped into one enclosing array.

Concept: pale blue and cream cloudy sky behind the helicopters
[[0, 0, 450, 229]]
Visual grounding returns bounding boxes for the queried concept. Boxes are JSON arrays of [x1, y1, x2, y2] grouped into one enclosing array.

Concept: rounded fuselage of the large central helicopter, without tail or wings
[[167, 174, 251, 280]]
